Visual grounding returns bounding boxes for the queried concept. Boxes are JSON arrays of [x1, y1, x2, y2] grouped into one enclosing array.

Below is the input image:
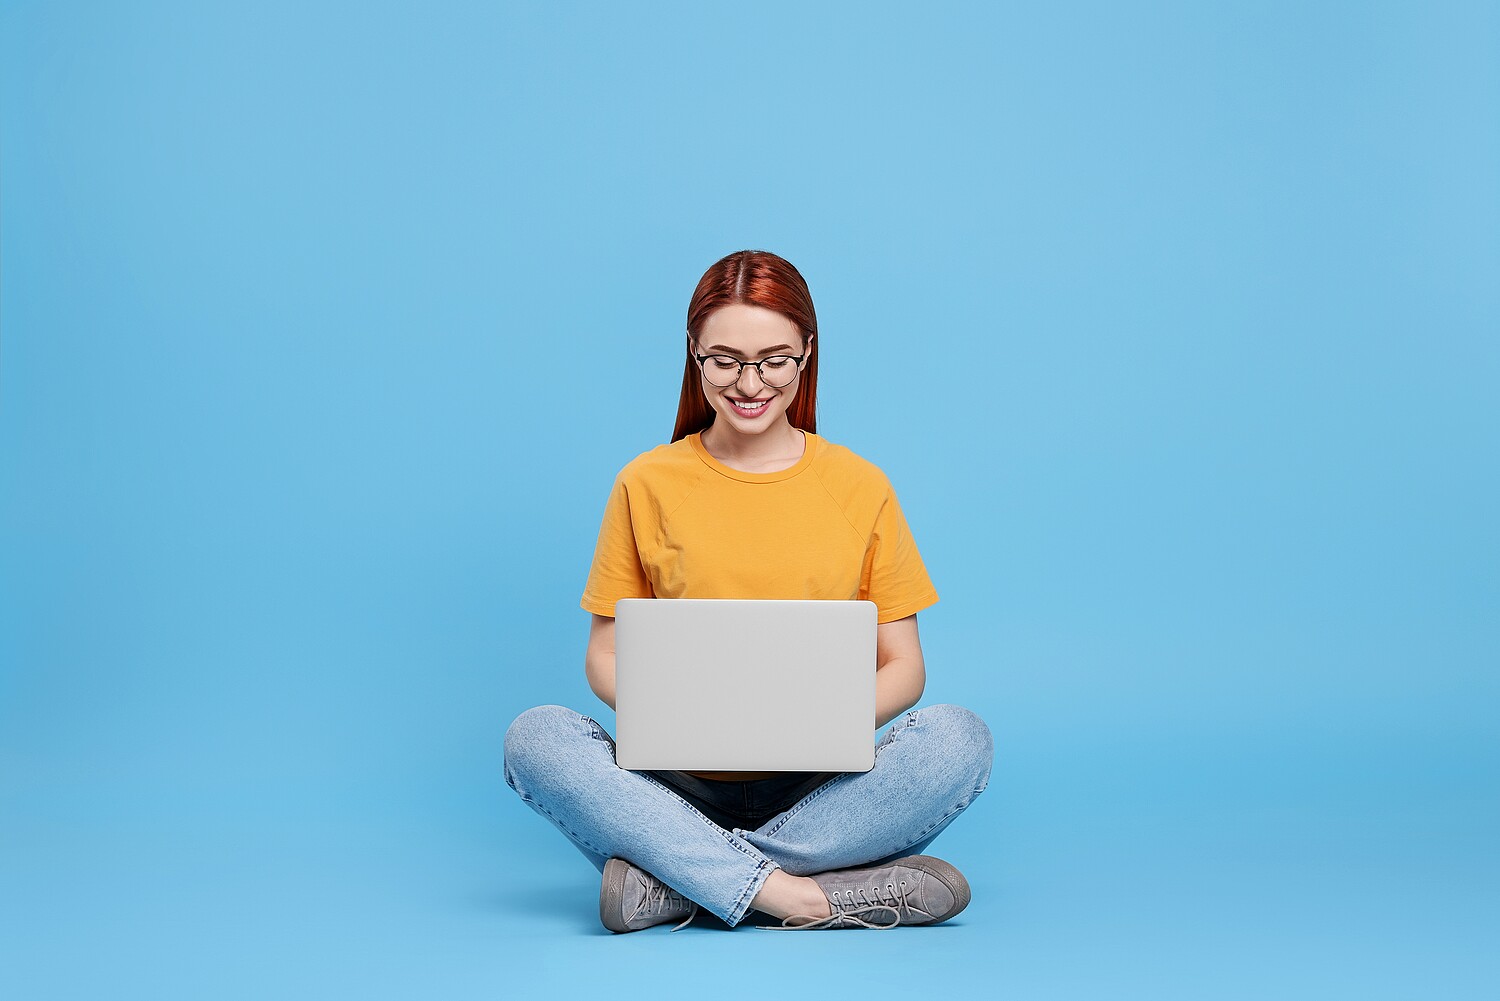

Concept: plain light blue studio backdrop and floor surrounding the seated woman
[[0, 2, 1500, 1001]]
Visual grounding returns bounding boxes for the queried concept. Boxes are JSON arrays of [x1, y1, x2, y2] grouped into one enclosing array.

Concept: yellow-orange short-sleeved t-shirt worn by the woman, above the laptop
[[582, 432, 938, 623]]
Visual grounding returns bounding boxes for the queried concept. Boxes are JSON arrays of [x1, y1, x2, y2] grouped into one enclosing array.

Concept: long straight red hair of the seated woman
[[672, 251, 822, 441]]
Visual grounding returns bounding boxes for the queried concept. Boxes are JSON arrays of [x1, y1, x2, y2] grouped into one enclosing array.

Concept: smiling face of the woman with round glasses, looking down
[[696, 303, 810, 434]]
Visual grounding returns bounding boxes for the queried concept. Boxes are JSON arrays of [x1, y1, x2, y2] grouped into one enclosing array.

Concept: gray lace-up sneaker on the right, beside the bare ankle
[[756, 855, 969, 932]]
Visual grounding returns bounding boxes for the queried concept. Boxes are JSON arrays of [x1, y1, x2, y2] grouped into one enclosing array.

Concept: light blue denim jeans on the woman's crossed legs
[[506, 705, 995, 927]]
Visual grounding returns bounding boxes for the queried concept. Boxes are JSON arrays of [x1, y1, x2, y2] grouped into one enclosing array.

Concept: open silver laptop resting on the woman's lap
[[615, 597, 876, 771]]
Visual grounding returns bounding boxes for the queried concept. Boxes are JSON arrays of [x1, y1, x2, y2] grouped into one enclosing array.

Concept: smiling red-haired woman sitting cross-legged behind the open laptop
[[506, 251, 993, 932]]
